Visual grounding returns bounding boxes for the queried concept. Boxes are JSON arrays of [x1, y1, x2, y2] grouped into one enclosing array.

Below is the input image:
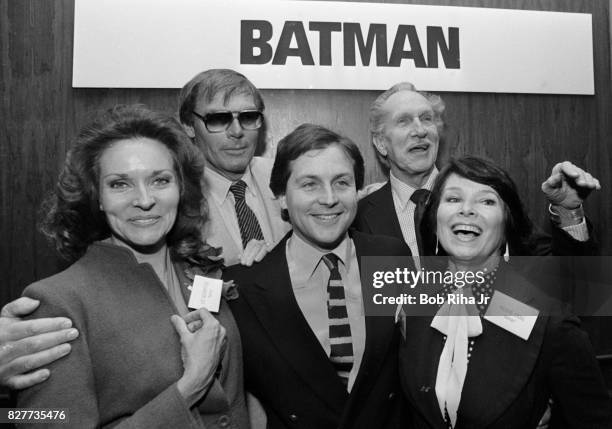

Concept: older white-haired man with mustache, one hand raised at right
[[354, 82, 600, 263]]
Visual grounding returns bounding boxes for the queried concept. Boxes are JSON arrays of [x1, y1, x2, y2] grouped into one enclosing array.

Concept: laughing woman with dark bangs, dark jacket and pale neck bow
[[400, 157, 610, 429]]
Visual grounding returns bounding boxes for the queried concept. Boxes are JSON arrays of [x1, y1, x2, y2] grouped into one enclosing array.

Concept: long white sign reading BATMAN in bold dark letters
[[73, 0, 594, 94]]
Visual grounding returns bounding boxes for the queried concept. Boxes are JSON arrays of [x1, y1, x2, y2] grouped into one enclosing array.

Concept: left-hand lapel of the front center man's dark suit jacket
[[240, 235, 348, 413]]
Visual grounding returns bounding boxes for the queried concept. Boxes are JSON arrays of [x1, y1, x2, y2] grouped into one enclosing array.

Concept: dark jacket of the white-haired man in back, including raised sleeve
[[353, 181, 599, 256]]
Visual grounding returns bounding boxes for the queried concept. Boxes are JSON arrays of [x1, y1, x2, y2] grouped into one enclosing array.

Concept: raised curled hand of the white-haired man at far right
[[542, 161, 601, 210]]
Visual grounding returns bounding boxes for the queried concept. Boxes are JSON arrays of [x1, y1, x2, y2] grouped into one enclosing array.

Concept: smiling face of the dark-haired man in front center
[[280, 144, 357, 251]]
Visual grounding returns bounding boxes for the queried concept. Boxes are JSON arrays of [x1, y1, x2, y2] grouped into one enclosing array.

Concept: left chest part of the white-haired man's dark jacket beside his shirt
[[364, 181, 404, 240]]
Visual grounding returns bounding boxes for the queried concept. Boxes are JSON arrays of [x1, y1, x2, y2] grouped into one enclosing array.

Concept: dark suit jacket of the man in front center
[[224, 232, 410, 429]]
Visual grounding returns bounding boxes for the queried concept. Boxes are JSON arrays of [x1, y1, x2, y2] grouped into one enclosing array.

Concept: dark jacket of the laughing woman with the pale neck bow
[[400, 265, 610, 429]]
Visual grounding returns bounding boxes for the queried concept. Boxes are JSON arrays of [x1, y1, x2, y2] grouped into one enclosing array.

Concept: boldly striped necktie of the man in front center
[[323, 253, 354, 386]]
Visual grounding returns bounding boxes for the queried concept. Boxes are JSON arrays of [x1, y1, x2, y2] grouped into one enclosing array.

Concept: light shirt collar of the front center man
[[287, 233, 357, 284]]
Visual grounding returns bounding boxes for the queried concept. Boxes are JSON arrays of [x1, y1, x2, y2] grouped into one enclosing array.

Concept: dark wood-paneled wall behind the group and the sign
[[0, 0, 612, 353]]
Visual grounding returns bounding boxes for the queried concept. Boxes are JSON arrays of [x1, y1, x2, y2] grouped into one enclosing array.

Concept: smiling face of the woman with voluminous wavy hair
[[99, 138, 180, 253]]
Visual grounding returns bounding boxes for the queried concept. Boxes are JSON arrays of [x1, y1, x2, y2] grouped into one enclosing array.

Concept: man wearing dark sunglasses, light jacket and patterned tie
[[179, 69, 290, 266]]
